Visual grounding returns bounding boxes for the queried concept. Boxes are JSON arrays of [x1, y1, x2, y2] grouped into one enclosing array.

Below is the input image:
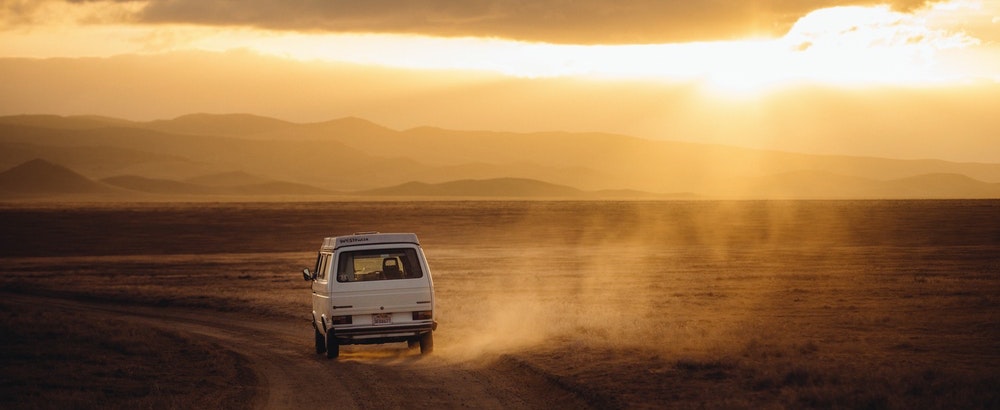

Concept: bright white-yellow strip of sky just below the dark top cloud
[[0, 1, 1000, 89]]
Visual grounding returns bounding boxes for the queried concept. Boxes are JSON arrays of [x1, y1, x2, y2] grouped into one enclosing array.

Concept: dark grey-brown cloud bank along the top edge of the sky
[[0, 0, 944, 44]]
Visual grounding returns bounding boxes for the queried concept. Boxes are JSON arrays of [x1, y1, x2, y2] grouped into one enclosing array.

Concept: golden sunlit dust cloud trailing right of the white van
[[427, 202, 838, 358]]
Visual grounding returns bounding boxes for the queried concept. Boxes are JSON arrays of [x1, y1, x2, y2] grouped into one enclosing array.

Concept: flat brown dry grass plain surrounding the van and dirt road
[[0, 201, 1000, 409]]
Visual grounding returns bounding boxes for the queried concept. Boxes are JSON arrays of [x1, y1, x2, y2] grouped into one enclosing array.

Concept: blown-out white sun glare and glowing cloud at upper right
[[686, 6, 978, 97]]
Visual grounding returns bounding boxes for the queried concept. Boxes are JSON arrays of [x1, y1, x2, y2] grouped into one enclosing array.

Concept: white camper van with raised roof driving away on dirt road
[[303, 232, 437, 358]]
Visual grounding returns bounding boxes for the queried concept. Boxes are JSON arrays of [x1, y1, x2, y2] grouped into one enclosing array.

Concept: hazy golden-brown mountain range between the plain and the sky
[[0, 114, 1000, 199]]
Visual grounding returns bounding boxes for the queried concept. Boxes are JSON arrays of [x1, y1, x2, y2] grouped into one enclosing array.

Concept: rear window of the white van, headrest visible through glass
[[337, 248, 424, 282]]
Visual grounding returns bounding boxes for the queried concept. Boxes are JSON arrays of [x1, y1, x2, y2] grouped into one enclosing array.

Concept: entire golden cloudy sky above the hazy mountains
[[0, 0, 1000, 162]]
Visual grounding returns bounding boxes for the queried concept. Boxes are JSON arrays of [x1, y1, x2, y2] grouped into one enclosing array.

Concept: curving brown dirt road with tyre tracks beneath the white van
[[4, 294, 596, 409]]
